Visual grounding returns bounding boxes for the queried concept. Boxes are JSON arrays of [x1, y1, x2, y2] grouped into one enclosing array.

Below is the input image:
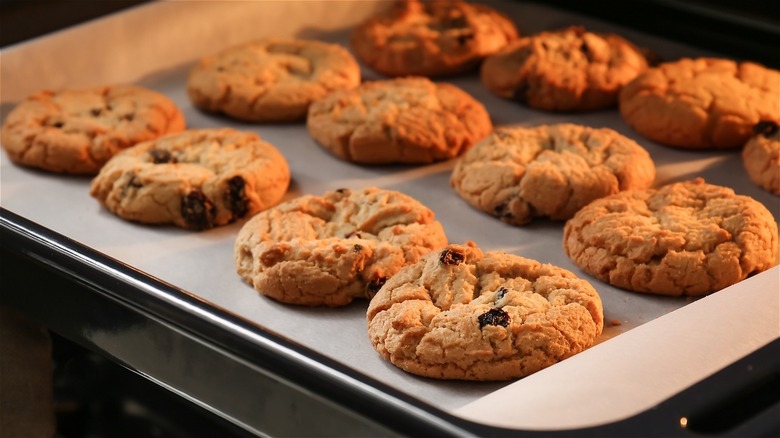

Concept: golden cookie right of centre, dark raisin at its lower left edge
[[450, 123, 655, 225]]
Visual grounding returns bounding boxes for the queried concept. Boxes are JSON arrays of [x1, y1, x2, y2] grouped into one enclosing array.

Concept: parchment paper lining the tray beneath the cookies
[[0, 1, 780, 429]]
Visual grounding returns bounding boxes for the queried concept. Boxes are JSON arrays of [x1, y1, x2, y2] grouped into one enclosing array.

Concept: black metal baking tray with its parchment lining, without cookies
[[0, 1, 780, 435]]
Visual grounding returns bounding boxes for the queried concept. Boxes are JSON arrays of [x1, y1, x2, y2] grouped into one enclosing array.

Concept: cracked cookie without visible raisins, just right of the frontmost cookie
[[563, 178, 778, 297]]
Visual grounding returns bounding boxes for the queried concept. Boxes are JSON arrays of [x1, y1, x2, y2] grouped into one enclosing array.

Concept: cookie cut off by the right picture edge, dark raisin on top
[[742, 122, 780, 195]]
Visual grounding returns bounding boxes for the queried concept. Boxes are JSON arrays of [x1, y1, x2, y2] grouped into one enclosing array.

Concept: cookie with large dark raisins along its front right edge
[[90, 128, 290, 230]]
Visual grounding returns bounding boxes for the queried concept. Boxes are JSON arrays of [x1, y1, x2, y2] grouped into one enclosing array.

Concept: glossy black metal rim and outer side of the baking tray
[[0, 209, 780, 437]]
